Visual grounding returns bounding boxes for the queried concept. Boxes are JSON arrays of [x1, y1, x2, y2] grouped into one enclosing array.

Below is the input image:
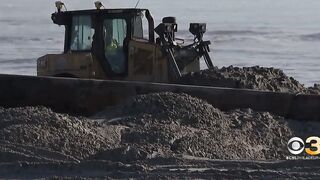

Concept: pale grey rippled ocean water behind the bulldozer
[[0, 0, 320, 86]]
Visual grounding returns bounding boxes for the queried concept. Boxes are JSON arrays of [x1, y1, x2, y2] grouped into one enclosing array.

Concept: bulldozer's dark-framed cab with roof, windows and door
[[42, 9, 154, 77]]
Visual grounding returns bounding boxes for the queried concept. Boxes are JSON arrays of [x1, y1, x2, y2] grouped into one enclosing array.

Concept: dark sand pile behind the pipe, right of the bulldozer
[[179, 66, 320, 94]]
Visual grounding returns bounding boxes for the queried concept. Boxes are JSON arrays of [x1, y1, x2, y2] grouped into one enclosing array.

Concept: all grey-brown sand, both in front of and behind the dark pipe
[[0, 66, 320, 179]]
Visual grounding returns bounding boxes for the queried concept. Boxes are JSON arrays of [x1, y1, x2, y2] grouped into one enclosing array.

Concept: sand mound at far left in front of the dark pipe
[[0, 107, 121, 159]]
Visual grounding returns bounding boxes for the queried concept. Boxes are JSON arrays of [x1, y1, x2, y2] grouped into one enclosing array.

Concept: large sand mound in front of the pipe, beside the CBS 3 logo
[[95, 93, 293, 161]]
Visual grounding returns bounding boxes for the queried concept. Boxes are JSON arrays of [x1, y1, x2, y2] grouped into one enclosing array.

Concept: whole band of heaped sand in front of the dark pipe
[[0, 93, 320, 163]]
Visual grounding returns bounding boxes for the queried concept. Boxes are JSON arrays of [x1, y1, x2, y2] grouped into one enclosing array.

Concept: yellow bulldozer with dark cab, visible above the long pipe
[[37, 2, 213, 83]]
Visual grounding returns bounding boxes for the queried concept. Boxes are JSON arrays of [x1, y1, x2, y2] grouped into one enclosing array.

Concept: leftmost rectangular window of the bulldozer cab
[[70, 16, 94, 51]]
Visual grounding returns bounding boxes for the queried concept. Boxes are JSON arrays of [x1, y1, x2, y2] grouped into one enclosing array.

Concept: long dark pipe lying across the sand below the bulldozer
[[0, 75, 320, 121]]
